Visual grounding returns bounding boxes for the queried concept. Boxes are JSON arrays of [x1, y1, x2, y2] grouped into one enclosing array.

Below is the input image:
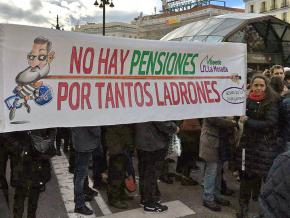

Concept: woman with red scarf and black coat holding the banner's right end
[[237, 74, 283, 218]]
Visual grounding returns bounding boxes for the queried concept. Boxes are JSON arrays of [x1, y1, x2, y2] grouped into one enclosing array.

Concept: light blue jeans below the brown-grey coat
[[203, 161, 223, 201]]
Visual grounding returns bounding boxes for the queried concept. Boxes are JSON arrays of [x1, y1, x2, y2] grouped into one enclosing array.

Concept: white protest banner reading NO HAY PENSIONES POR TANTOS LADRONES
[[0, 24, 246, 132]]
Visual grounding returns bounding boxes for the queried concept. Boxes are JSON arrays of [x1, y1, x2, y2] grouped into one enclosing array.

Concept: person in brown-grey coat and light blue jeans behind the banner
[[199, 117, 237, 211]]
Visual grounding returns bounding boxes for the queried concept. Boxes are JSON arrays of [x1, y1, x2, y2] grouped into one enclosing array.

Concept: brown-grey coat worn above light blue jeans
[[199, 117, 236, 162]]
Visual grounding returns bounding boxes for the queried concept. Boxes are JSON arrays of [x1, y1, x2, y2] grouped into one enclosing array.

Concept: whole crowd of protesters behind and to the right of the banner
[[0, 65, 290, 218]]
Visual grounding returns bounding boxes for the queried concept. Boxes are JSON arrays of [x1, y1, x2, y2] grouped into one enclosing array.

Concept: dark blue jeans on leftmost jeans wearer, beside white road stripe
[[74, 151, 92, 208]]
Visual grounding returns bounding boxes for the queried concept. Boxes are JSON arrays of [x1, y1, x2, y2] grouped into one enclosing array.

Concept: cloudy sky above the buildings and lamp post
[[0, 0, 244, 30]]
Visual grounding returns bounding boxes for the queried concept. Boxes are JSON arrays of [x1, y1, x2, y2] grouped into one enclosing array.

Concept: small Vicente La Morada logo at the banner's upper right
[[200, 55, 229, 73]]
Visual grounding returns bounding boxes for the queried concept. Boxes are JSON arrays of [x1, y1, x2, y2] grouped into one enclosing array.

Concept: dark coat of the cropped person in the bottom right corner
[[259, 151, 290, 218]]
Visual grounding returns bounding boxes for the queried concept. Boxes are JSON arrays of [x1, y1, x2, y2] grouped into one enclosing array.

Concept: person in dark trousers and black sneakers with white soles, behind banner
[[135, 121, 179, 213]]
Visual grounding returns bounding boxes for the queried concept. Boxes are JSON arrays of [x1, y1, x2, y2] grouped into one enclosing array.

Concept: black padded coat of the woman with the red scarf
[[237, 99, 282, 177]]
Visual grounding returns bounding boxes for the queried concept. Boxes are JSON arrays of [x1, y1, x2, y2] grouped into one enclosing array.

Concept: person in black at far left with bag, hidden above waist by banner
[[13, 128, 56, 218]]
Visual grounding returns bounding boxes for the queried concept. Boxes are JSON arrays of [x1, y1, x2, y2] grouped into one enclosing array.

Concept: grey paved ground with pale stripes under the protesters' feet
[[0, 155, 258, 218]]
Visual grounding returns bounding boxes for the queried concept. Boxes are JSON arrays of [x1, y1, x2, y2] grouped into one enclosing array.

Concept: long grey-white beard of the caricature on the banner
[[15, 64, 50, 85]]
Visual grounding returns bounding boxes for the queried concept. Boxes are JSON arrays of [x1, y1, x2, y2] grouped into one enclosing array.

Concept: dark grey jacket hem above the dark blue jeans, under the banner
[[71, 126, 101, 152]]
